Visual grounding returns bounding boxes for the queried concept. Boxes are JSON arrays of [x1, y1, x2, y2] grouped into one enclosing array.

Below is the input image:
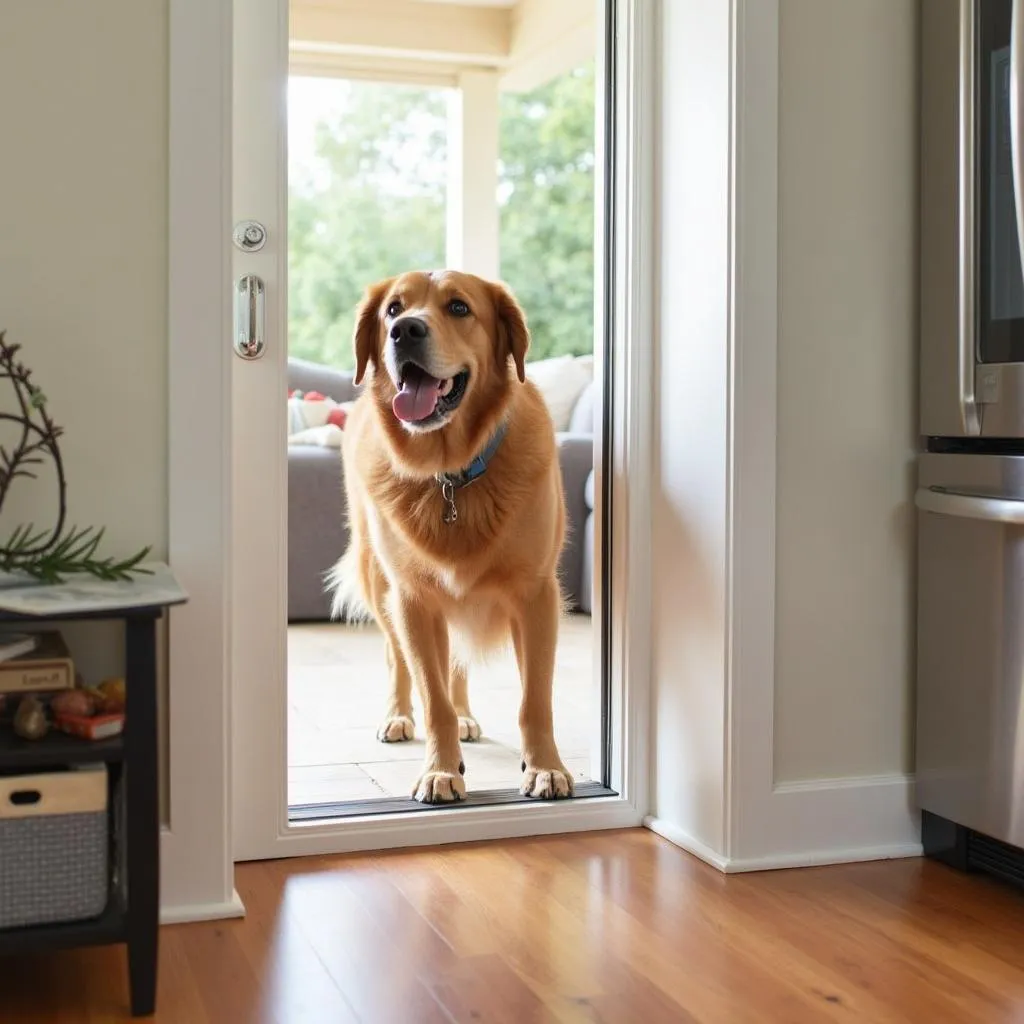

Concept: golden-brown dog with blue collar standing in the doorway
[[328, 271, 572, 804]]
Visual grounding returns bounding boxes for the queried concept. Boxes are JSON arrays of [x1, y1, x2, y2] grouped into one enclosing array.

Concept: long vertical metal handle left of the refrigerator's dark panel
[[956, 0, 983, 437]]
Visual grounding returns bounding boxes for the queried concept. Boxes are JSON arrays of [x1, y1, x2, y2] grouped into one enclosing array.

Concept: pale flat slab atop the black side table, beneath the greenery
[[0, 562, 188, 615]]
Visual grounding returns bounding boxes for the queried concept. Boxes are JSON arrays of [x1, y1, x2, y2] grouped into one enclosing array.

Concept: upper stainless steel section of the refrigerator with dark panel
[[920, 0, 1024, 447]]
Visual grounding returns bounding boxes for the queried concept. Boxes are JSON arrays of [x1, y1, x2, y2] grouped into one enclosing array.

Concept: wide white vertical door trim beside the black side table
[[161, 0, 242, 921]]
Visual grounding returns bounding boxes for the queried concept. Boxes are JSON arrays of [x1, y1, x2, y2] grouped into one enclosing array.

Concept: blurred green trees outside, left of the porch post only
[[288, 82, 447, 370]]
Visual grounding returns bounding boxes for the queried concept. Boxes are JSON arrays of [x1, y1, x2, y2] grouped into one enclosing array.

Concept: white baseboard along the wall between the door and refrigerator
[[644, 774, 923, 873]]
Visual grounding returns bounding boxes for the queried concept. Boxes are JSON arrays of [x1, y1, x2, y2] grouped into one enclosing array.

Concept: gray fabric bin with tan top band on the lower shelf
[[0, 766, 110, 929]]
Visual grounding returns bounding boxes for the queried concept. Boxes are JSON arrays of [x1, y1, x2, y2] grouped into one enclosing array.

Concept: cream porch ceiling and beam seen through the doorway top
[[290, 0, 597, 91]]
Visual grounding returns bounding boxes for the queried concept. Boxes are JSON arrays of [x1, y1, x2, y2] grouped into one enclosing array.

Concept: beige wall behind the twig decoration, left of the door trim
[[0, 0, 167, 802]]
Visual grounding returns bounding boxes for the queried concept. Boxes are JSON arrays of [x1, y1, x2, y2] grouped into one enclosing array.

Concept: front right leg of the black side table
[[124, 615, 160, 1017]]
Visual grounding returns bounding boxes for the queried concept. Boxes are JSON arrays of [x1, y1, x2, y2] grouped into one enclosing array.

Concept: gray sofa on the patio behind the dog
[[288, 359, 597, 623]]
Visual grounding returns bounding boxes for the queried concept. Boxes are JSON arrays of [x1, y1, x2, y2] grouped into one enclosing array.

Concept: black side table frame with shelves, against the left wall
[[0, 604, 180, 1017]]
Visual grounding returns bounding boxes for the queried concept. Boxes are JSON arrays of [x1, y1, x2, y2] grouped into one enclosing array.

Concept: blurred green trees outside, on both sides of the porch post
[[289, 63, 594, 369]]
